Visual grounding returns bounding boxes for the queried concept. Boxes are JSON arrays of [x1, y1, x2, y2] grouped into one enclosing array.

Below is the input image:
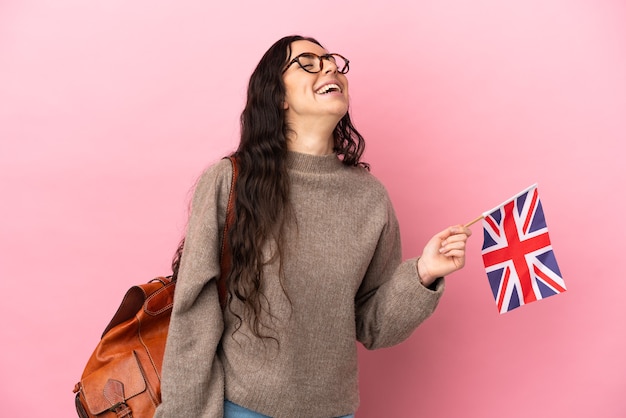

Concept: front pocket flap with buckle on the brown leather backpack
[[81, 351, 146, 415]]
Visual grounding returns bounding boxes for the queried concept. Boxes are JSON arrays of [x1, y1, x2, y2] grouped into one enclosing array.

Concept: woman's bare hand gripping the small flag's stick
[[417, 225, 472, 286]]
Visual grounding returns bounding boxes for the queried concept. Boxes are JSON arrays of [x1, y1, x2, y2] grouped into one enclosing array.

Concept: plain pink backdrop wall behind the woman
[[0, 0, 626, 418]]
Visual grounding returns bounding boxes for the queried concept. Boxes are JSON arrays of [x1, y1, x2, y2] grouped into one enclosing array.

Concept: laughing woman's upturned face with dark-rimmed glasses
[[283, 40, 349, 127]]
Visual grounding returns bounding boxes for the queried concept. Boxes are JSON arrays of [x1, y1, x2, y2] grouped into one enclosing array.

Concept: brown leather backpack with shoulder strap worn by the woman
[[74, 157, 237, 418]]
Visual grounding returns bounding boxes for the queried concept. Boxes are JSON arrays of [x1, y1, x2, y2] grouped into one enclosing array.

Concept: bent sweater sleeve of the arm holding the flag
[[355, 195, 444, 350]]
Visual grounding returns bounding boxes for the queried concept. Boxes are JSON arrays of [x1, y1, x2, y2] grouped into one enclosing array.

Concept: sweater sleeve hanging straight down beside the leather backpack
[[154, 160, 232, 418]]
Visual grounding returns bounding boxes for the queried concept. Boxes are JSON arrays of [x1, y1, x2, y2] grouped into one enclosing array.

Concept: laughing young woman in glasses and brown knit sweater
[[156, 36, 471, 418]]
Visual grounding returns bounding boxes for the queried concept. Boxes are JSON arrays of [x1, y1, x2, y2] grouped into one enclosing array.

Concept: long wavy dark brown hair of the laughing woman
[[172, 35, 369, 338]]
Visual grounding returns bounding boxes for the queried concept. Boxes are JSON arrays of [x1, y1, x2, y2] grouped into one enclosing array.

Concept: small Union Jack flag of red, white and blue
[[482, 184, 566, 314]]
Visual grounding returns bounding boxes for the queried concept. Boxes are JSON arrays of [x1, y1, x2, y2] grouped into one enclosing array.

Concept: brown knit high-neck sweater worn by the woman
[[155, 152, 443, 418]]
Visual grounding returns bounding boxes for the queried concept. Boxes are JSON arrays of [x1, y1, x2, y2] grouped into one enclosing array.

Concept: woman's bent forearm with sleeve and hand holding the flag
[[355, 198, 471, 349]]
